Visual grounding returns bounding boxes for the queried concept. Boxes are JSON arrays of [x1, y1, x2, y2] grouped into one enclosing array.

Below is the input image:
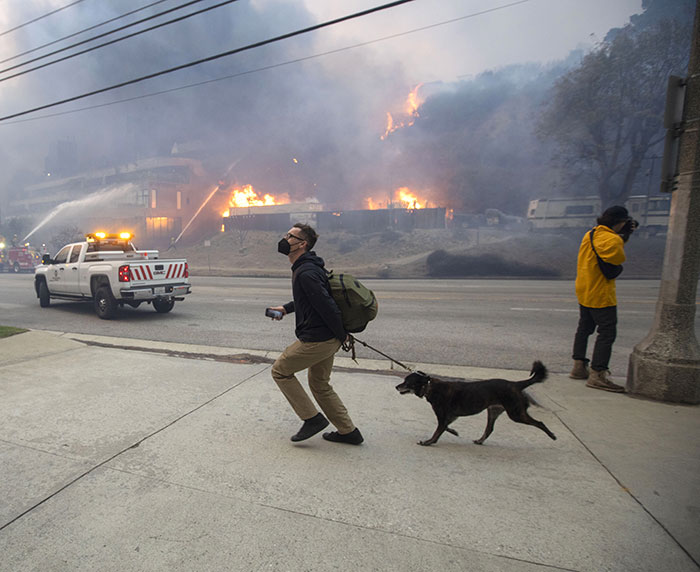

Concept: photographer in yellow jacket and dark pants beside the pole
[[569, 206, 637, 393]]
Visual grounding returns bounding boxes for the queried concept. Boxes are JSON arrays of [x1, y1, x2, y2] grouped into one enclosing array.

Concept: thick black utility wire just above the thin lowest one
[[0, 0, 416, 121]]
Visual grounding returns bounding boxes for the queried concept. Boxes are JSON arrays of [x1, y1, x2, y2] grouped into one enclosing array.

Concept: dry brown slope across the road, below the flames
[[172, 228, 665, 279]]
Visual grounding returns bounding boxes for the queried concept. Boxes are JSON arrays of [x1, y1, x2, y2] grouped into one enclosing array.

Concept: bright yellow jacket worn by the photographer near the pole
[[576, 225, 625, 308]]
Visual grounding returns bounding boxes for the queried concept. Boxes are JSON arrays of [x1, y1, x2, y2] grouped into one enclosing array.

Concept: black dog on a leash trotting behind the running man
[[396, 361, 556, 445]]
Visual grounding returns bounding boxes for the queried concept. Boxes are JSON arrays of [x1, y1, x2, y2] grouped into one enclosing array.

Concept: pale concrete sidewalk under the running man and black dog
[[0, 331, 700, 572]]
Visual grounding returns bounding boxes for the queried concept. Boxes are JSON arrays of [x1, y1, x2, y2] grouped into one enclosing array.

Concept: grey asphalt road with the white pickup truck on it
[[0, 274, 697, 378]]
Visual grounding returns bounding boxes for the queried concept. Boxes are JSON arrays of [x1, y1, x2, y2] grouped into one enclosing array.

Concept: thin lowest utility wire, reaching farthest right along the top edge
[[0, 0, 530, 125]]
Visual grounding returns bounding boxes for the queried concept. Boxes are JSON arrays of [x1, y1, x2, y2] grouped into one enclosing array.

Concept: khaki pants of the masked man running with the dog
[[272, 338, 355, 434]]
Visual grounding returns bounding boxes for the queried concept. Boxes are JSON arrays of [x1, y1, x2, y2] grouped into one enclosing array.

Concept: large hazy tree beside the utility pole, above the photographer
[[538, 16, 691, 207]]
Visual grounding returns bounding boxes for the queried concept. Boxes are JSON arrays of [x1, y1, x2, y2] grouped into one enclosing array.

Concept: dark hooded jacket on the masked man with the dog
[[284, 251, 347, 342]]
